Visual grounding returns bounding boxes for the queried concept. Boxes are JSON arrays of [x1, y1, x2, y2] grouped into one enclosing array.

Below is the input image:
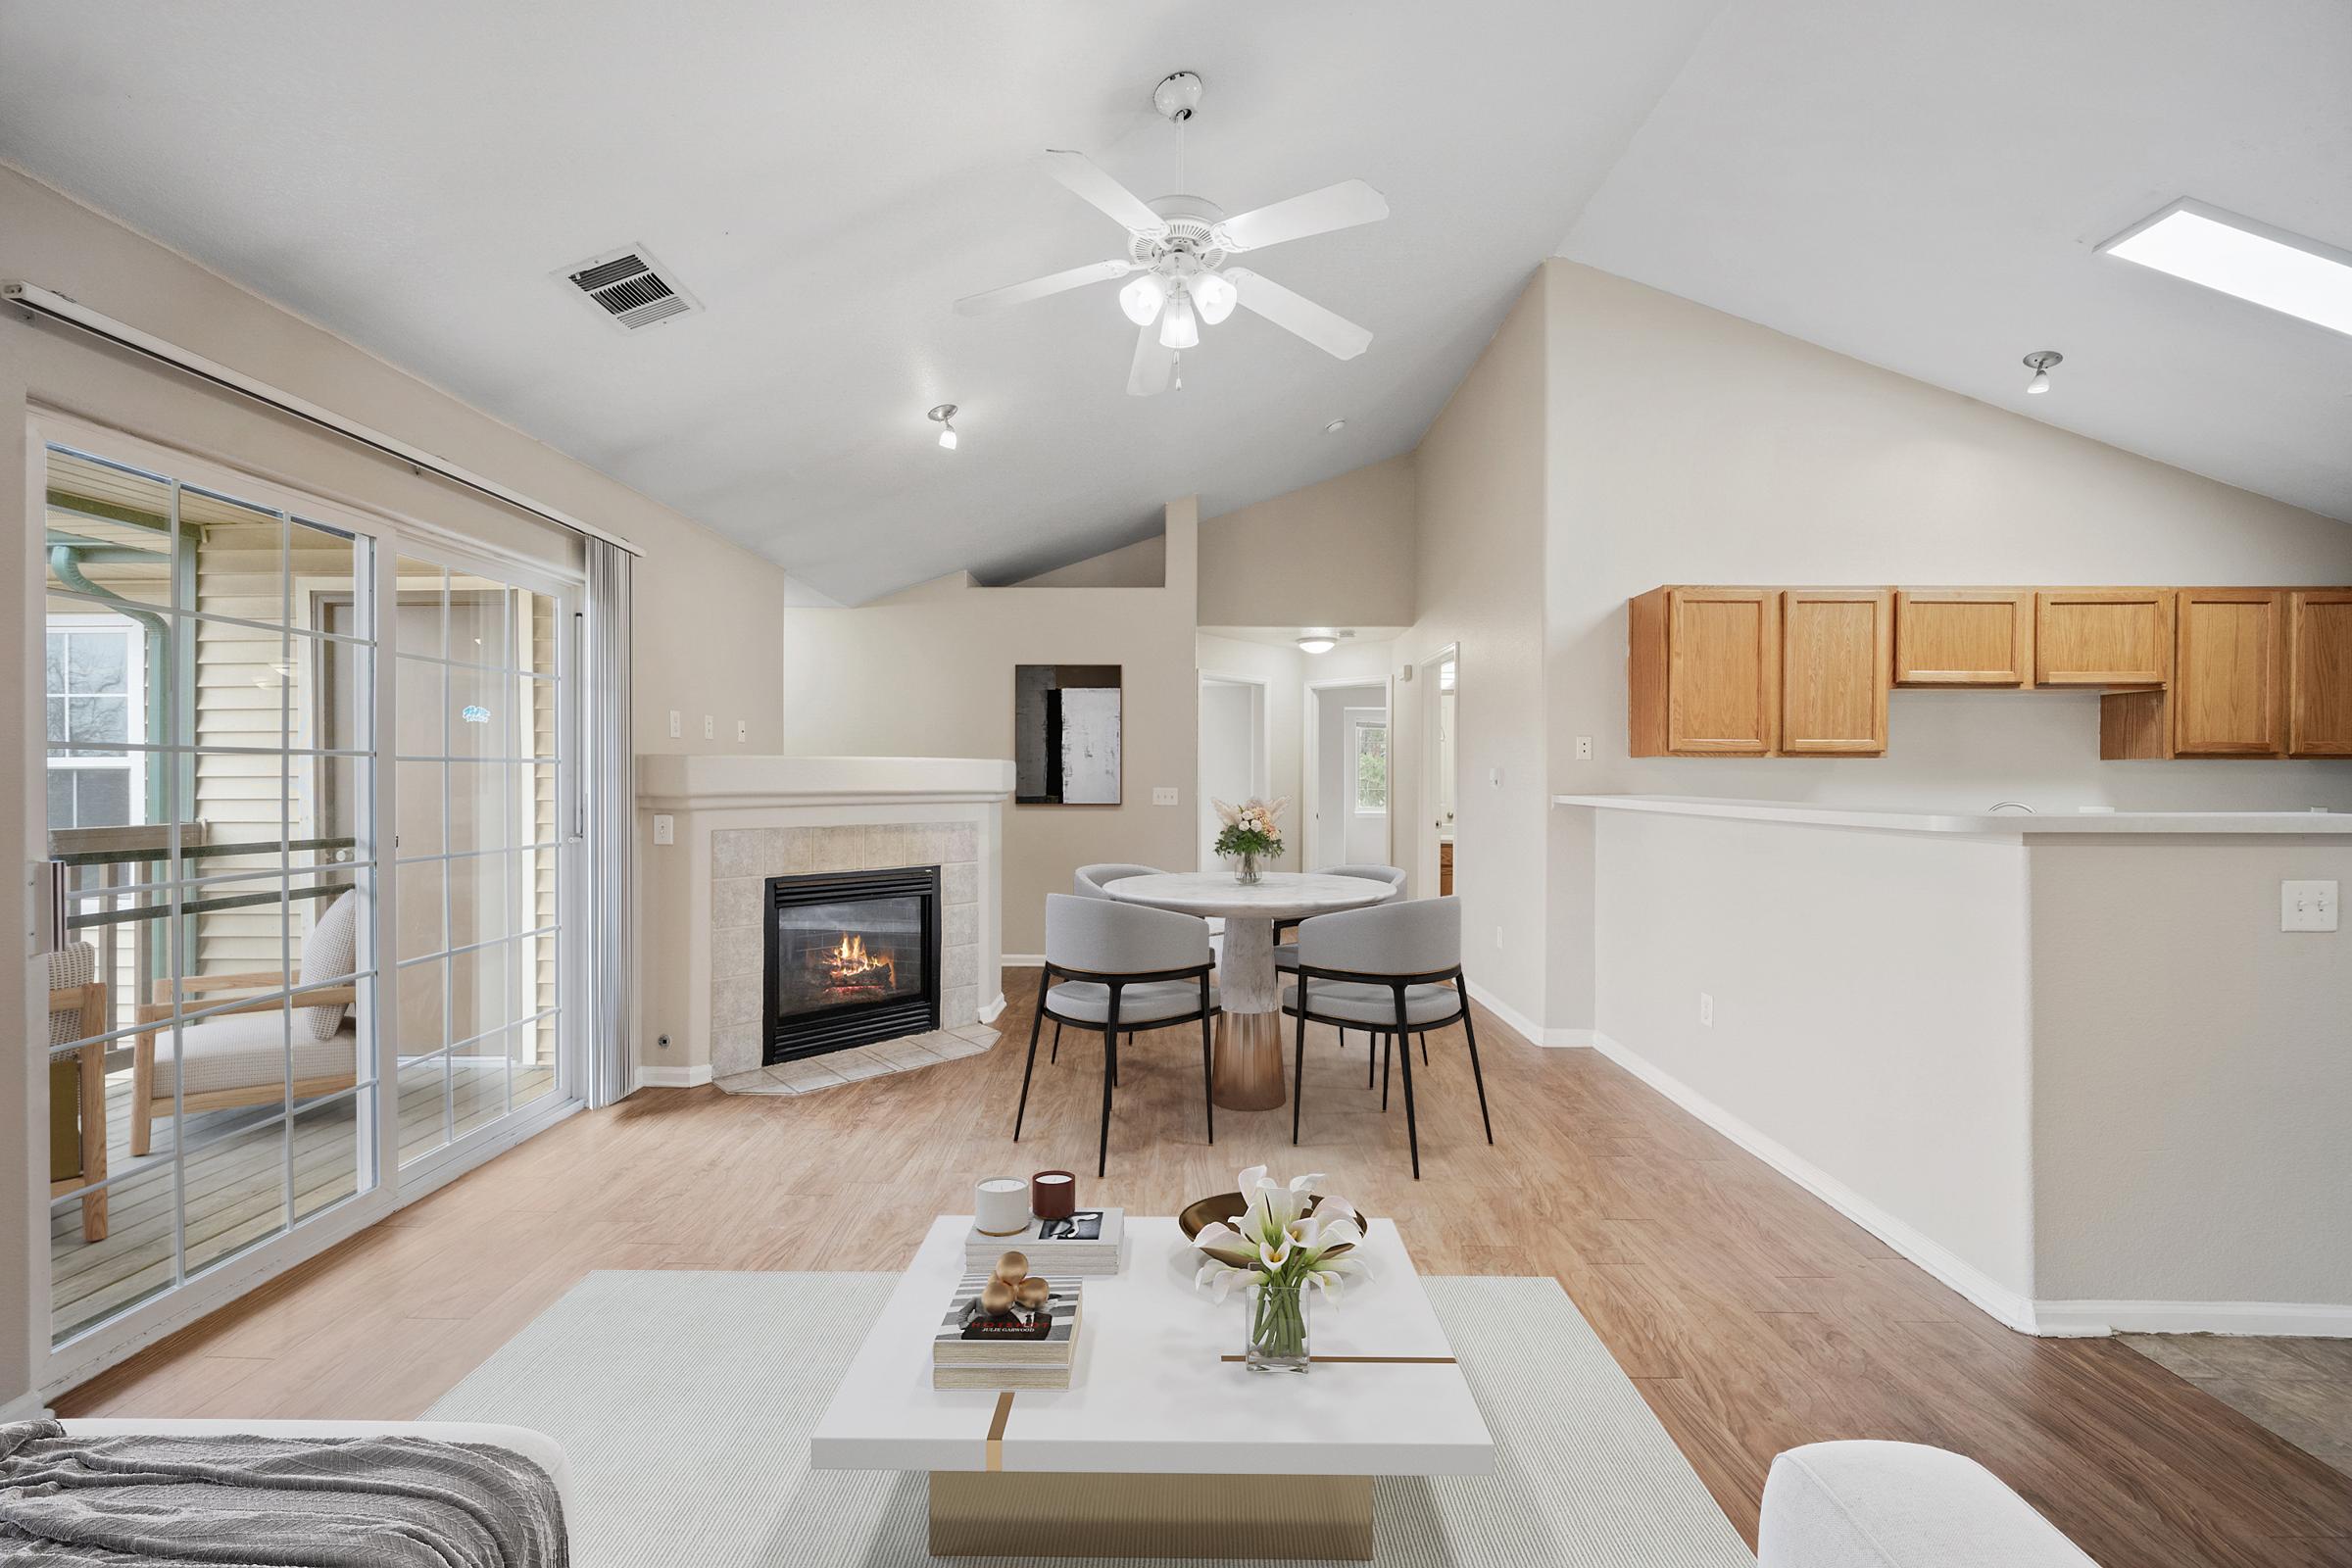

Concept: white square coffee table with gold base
[[809, 1215, 1494, 1558]]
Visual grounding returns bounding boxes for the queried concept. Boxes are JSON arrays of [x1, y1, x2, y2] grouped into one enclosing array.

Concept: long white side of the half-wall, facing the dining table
[[1590, 811, 2034, 1300]]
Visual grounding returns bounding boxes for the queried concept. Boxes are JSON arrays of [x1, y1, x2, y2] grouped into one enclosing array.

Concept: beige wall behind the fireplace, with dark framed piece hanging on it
[[781, 499, 1200, 956]]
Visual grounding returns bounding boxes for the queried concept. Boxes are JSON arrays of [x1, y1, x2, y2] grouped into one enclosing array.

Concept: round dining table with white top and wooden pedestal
[[1103, 872, 1397, 1109]]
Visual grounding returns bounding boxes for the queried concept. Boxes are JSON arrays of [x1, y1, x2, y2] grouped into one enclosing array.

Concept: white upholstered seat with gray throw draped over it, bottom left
[[0, 1420, 569, 1568]]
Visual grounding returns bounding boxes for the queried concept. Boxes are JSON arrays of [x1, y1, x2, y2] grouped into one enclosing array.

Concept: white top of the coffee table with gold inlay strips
[[809, 1215, 1494, 1476]]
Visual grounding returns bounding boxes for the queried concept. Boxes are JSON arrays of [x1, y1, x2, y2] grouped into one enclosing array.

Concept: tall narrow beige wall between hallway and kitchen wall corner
[[1390, 272, 1547, 1025]]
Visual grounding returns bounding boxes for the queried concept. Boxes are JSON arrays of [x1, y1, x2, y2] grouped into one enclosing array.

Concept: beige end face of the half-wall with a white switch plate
[[2030, 839, 2352, 1333]]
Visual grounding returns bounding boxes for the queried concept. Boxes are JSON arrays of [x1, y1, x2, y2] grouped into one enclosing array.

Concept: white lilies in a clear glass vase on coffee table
[[1193, 1166, 1371, 1371]]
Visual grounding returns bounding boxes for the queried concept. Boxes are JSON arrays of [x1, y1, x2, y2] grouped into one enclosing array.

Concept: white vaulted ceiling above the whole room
[[0, 0, 2352, 602]]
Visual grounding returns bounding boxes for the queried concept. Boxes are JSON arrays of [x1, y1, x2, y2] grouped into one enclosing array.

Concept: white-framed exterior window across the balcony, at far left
[[42, 615, 146, 827]]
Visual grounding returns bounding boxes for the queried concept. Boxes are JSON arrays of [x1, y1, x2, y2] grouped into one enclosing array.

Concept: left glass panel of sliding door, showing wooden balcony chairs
[[40, 434, 376, 1343]]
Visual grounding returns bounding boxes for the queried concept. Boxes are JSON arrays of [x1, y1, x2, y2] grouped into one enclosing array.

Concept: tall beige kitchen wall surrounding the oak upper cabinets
[[1543, 261, 2352, 1027]]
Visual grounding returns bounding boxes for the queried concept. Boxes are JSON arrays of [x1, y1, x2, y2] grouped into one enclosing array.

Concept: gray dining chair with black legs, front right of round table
[[1282, 898, 1494, 1180]]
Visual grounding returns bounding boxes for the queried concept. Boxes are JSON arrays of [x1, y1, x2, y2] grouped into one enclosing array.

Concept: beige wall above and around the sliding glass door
[[0, 167, 783, 1405]]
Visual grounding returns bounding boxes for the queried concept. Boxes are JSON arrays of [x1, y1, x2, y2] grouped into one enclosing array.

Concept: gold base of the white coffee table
[[931, 1469, 1371, 1563]]
